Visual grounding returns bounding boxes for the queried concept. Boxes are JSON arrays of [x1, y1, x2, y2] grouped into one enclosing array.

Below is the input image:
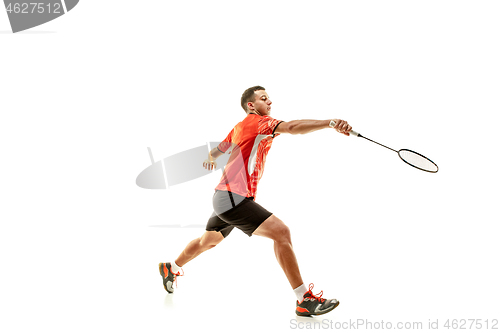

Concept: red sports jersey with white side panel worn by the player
[[215, 113, 282, 198]]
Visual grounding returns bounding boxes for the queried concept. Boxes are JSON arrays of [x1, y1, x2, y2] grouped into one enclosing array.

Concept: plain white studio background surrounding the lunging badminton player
[[0, 0, 500, 332]]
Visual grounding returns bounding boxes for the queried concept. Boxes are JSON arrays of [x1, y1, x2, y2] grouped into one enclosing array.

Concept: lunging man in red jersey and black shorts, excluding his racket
[[159, 86, 351, 316]]
